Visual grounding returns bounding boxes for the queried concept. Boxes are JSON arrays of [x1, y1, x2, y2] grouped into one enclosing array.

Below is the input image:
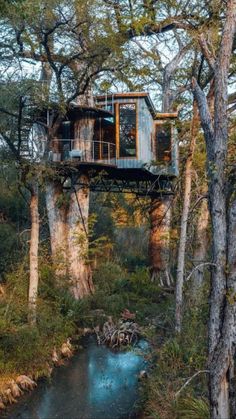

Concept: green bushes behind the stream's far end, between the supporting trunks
[[90, 262, 169, 325]]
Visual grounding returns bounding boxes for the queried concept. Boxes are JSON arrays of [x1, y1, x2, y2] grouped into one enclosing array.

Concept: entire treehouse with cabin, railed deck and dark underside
[[49, 93, 178, 194]]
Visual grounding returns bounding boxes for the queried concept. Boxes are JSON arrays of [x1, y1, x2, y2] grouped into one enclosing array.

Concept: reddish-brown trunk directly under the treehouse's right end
[[149, 195, 173, 286]]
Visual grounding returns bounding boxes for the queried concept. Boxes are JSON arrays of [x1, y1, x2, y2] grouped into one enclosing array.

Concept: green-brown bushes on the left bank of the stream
[[0, 260, 78, 376]]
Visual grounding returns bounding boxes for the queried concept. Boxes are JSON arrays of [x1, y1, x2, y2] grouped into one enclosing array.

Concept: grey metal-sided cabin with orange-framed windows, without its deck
[[95, 93, 178, 176]]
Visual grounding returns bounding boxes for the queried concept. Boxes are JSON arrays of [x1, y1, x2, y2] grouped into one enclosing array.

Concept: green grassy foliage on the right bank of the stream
[[146, 297, 209, 419]]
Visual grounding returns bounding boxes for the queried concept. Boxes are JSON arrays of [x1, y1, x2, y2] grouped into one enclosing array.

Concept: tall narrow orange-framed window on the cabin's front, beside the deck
[[119, 103, 137, 157]]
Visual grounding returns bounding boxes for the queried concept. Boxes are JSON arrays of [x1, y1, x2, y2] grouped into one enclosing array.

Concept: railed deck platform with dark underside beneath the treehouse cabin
[[49, 139, 175, 196]]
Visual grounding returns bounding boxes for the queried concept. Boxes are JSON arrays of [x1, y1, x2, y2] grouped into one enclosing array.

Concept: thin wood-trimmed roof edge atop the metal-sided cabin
[[95, 92, 178, 120]]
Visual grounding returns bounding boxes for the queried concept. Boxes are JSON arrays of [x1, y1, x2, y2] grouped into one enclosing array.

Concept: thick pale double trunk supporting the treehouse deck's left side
[[46, 90, 94, 299]]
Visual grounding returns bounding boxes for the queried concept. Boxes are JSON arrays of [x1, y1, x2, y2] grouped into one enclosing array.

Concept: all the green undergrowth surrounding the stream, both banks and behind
[[0, 255, 209, 419]]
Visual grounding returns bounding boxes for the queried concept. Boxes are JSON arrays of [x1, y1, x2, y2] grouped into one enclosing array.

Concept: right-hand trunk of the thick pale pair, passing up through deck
[[67, 87, 95, 299]]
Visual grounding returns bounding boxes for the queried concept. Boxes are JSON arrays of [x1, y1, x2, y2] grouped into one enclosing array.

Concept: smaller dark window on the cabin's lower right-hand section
[[156, 123, 171, 163]]
